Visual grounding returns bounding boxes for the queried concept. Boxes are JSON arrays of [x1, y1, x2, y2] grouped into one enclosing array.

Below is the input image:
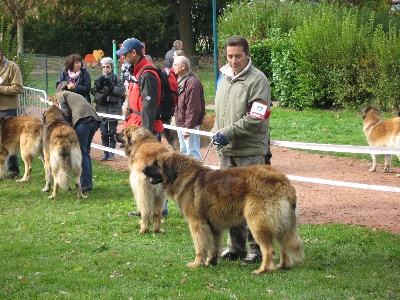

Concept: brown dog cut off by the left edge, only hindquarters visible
[[0, 116, 43, 182]]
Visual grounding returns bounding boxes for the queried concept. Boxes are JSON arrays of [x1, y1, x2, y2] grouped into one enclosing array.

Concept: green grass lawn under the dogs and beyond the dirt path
[[0, 107, 400, 299]]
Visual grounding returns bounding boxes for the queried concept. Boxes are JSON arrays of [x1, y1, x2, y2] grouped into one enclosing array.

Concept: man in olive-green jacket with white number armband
[[213, 36, 271, 264]]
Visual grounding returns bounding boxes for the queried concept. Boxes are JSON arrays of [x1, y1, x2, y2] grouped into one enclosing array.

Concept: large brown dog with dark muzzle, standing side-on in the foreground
[[143, 153, 304, 274]]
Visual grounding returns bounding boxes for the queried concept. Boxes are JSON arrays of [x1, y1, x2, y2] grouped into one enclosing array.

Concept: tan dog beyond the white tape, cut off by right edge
[[362, 106, 400, 177]]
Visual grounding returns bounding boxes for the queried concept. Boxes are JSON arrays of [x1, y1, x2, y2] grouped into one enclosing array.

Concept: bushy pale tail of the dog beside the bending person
[[50, 139, 72, 191]]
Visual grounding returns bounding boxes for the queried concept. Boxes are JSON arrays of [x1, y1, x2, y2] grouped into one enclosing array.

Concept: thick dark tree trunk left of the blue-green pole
[[175, 0, 196, 56]]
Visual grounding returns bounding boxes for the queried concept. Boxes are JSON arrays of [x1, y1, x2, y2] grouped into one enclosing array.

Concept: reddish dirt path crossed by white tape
[[92, 126, 400, 234]]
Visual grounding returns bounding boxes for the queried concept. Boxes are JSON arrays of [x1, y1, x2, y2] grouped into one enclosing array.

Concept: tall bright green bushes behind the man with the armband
[[218, 0, 400, 110]]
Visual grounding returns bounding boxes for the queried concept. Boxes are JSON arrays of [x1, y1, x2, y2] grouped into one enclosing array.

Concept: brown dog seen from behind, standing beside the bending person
[[42, 105, 86, 199]]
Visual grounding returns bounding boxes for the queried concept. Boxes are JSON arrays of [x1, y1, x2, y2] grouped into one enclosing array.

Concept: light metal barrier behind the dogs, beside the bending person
[[17, 86, 48, 119]]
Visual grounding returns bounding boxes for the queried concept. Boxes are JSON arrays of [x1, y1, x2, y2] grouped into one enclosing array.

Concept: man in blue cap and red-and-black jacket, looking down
[[117, 38, 164, 137]]
